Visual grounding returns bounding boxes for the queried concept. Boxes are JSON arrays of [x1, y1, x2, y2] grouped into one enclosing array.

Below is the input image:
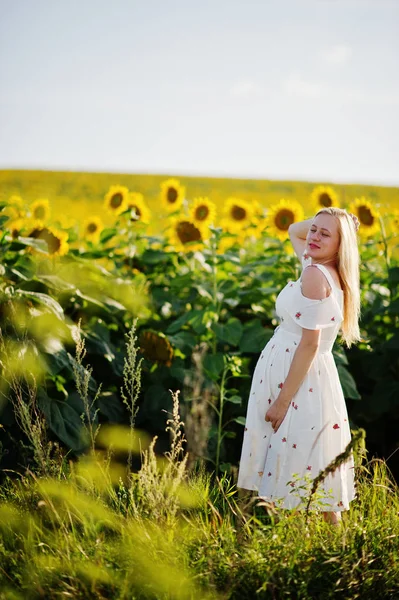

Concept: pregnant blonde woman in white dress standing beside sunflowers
[[237, 208, 360, 524]]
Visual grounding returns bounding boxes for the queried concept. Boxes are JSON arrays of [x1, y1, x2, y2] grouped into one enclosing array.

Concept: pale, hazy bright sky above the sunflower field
[[0, 0, 399, 185]]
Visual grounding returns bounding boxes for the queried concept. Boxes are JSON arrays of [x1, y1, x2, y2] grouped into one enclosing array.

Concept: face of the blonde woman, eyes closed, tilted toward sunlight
[[306, 213, 340, 262]]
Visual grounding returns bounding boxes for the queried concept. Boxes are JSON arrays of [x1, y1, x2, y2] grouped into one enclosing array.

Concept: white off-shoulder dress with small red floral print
[[237, 253, 355, 511]]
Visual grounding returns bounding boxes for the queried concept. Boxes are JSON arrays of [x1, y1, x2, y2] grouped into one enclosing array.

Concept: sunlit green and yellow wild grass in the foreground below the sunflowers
[[0, 328, 399, 600]]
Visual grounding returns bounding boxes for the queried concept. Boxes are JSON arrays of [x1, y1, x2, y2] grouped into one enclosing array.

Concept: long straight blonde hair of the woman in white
[[315, 206, 362, 348]]
